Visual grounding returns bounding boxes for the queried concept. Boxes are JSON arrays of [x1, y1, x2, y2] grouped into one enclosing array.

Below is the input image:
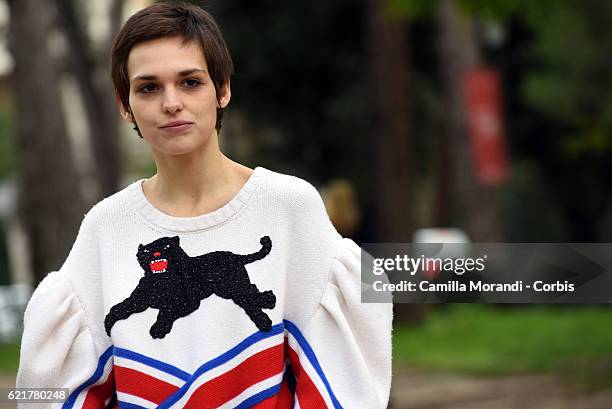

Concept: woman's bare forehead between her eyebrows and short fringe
[[127, 37, 207, 81]]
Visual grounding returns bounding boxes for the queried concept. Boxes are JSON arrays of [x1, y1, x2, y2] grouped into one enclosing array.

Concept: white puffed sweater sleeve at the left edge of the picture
[[17, 271, 114, 408]]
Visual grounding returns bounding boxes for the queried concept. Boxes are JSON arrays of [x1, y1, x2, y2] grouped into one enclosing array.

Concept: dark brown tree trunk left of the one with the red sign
[[368, 0, 413, 242]]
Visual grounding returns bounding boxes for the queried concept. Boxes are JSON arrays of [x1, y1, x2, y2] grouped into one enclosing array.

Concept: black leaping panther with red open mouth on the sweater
[[104, 236, 276, 338]]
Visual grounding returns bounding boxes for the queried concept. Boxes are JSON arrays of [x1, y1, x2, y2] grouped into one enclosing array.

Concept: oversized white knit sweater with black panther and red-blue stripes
[[17, 168, 392, 409]]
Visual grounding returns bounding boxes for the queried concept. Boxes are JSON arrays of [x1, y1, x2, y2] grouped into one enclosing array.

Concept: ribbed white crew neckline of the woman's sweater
[[128, 166, 266, 232]]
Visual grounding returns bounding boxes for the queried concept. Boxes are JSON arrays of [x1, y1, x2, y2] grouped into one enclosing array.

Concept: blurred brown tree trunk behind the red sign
[[438, 0, 501, 242]]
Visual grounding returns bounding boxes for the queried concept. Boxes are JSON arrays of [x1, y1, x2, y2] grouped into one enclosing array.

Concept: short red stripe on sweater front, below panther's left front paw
[[115, 365, 179, 405]]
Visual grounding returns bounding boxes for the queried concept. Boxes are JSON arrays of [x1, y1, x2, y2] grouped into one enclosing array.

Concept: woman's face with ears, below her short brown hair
[[121, 37, 230, 155]]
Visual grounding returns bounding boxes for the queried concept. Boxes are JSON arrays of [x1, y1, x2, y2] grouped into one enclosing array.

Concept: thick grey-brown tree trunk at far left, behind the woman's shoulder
[[9, 0, 84, 283]]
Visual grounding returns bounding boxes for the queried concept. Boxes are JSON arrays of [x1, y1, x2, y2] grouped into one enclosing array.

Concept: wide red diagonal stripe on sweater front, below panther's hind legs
[[185, 344, 284, 409]]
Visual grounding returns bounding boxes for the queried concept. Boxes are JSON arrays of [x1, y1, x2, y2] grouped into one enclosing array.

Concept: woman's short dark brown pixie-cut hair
[[110, 1, 234, 133]]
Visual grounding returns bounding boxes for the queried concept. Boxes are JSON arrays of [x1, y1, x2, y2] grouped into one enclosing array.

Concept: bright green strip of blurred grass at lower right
[[393, 304, 612, 387]]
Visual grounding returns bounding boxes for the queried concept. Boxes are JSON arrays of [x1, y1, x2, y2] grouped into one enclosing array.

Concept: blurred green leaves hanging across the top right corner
[[388, 0, 612, 155]]
